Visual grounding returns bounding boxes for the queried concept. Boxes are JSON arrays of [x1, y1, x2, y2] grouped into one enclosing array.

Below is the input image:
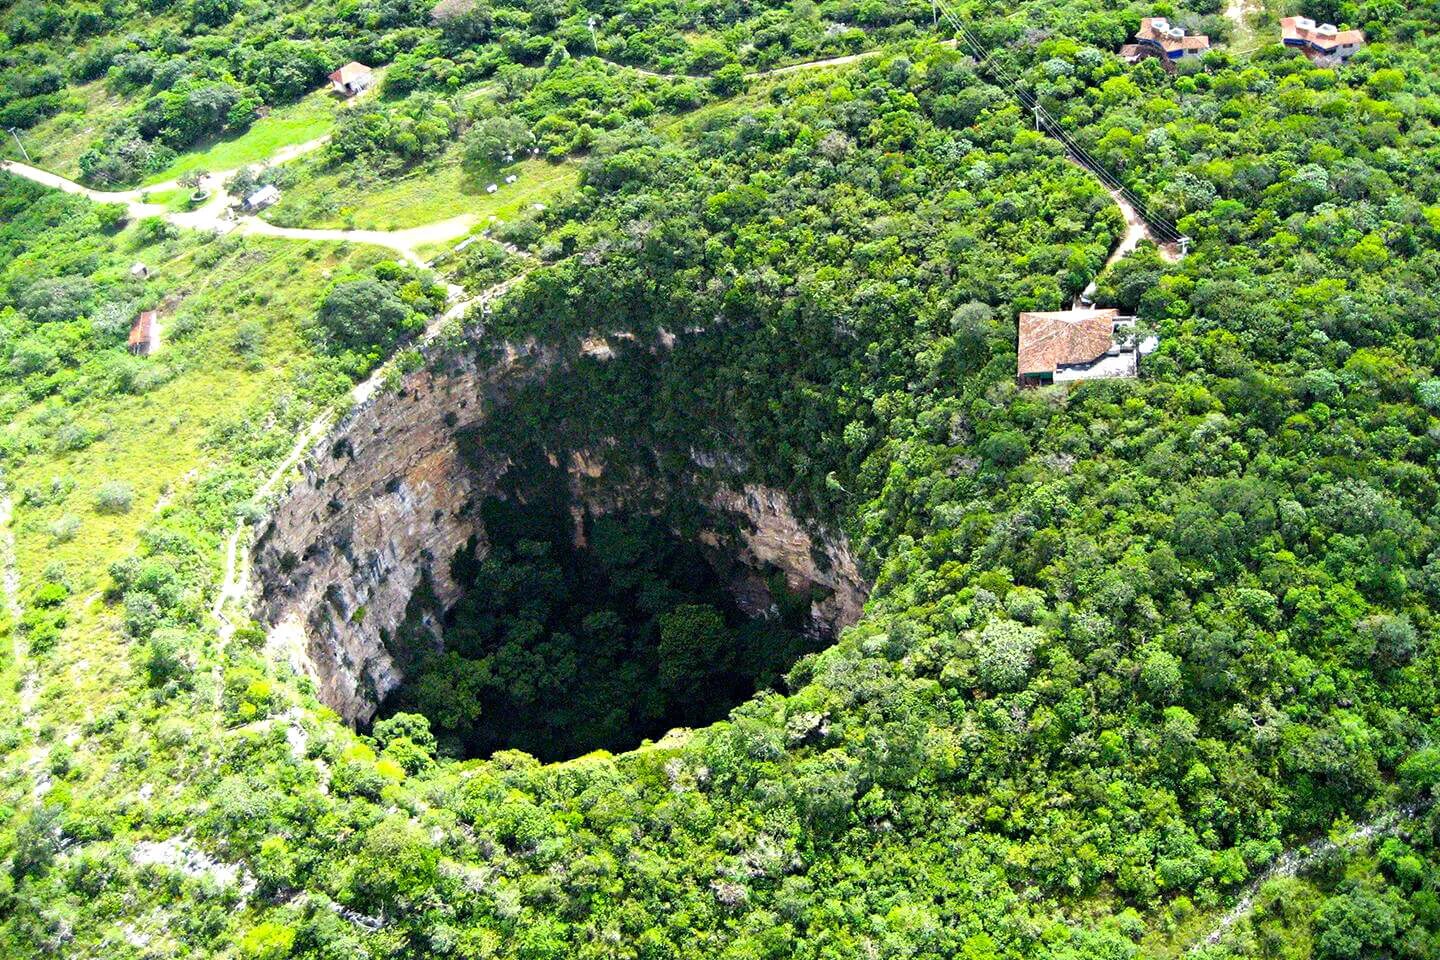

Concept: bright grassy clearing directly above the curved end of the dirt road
[[265, 148, 579, 230]]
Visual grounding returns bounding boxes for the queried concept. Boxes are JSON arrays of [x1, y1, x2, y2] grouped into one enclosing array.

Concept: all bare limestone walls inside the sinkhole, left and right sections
[[252, 333, 868, 723]]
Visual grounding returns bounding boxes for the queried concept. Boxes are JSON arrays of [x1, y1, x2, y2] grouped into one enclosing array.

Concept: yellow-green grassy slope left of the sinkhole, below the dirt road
[[7, 228, 383, 742]]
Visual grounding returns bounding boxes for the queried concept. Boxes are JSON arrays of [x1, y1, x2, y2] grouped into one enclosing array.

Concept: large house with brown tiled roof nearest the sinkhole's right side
[[1015, 308, 1153, 387]]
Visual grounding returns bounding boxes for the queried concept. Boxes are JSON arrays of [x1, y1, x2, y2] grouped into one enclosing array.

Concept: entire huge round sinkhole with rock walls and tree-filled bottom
[[251, 341, 870, 760]]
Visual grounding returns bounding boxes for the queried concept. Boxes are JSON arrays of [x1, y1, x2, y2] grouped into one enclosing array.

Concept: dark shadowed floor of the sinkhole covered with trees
[[377, 468, 829, 761]]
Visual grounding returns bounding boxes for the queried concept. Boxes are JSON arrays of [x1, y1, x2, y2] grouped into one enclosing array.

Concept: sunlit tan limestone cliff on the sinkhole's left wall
[[252, 344, 557, 723]]
